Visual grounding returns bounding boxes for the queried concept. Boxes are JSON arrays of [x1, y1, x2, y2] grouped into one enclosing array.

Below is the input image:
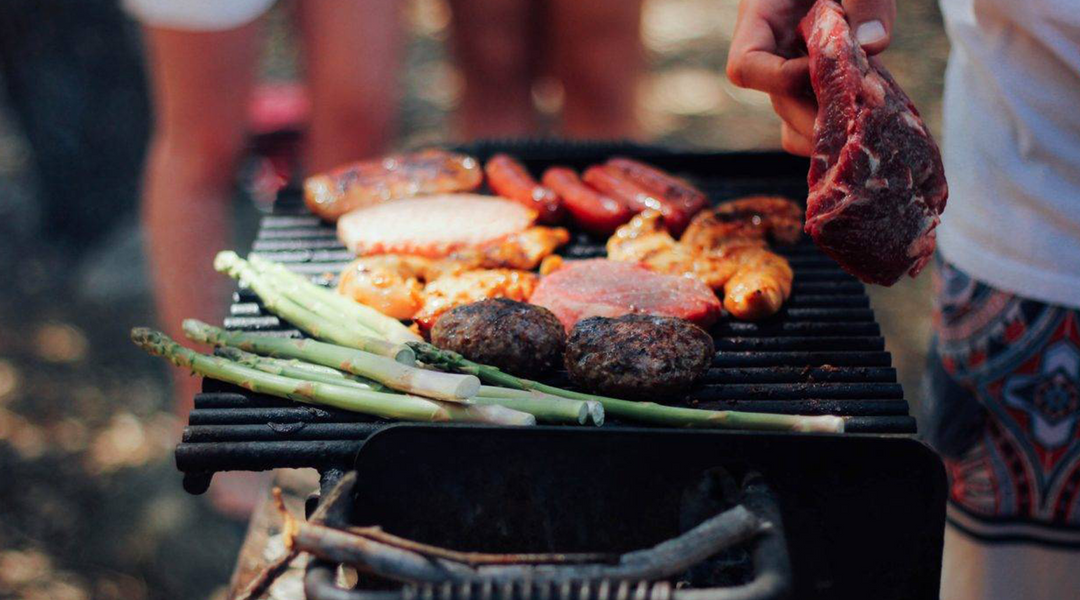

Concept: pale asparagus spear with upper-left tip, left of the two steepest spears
[[214, 250, 416, 365]]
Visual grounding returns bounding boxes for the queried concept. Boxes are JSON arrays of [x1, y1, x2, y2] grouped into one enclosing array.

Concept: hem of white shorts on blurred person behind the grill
[[123, 0, 275, 31]]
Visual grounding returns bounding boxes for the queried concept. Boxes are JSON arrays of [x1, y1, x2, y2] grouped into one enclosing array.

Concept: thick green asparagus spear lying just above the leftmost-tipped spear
[[184, 318, 480, 403]]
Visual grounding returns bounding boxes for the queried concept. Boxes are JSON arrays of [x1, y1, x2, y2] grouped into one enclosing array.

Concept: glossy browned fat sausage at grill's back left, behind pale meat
[[303, 149, 484, 221]]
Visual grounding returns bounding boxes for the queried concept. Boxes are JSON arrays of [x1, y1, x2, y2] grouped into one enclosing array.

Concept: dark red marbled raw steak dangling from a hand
[[799, 0, 948, 285]]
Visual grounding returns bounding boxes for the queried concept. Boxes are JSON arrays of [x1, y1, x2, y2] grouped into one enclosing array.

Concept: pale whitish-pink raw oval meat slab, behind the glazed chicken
[[338, 194, 537, 258]]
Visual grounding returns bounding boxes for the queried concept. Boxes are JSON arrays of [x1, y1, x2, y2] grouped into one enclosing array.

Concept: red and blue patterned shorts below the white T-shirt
[[924, 258, 1080, 548]]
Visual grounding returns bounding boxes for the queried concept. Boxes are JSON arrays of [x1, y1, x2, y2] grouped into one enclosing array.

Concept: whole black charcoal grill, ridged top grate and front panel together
[[176, 142, 945, 600]]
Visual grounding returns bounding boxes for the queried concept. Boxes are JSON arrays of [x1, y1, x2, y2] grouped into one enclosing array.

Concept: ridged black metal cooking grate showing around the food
[[176, 142, 915, 492]]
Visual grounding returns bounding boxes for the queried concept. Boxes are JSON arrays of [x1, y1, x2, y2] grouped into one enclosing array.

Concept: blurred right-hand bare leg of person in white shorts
[[297, 0, 402, 172]]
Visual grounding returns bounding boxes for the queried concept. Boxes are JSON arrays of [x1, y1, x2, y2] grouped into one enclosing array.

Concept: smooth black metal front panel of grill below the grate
[[304, 424, 945, 600]]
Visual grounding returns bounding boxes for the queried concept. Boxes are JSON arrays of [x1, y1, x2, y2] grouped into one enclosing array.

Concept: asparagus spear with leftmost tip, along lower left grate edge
[[132, 327, 536, 425]]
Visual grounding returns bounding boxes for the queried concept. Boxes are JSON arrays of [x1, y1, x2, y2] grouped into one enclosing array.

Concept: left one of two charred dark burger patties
[[431, 298, 566, 377]]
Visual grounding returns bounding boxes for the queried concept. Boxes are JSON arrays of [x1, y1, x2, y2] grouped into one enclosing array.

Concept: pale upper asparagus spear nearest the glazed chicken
[[247, 255, 423, 343]]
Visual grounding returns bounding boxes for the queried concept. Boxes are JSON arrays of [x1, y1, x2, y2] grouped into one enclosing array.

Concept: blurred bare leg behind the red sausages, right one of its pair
[[549, 0, 643, 138]]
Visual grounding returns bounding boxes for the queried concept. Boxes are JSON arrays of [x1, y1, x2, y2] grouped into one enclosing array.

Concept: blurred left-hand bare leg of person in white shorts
[[143, 24, 258, 417]]
